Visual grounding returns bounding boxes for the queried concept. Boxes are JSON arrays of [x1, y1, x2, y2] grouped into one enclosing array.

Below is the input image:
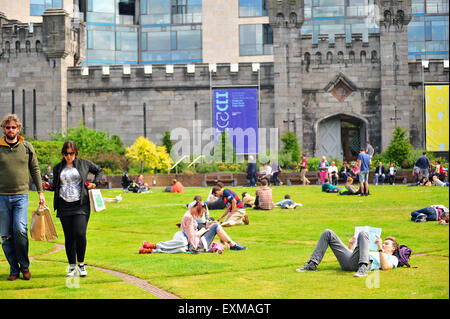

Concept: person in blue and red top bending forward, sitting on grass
[[212, 186, 249, 226]]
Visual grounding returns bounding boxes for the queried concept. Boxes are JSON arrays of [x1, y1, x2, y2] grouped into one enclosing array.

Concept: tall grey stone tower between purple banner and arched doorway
[[269, 0, 304, 145]]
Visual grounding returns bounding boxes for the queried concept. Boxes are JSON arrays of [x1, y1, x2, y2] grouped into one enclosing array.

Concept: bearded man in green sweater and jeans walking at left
[[0, 114, 45, 281]]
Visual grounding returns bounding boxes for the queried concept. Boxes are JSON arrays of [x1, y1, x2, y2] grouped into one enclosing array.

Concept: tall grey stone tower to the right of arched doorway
[[375, 0, 412, 151]]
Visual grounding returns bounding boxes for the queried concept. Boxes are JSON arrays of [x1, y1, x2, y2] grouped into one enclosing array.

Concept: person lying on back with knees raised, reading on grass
[[296, 229, 399, 277]]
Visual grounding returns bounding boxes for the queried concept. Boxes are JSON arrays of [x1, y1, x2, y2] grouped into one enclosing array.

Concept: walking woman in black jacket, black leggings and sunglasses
[[52, 141, 103, 277]]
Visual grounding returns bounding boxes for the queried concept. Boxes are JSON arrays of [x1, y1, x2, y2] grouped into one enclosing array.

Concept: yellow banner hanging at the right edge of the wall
[[425, 84, 449, 151]]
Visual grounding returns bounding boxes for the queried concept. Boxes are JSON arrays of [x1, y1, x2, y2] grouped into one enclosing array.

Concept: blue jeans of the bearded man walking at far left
[[0, 194, 30, 275]]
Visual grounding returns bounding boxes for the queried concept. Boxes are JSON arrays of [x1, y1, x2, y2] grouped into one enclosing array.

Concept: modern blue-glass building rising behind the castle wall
[[22, 0, 449, 65]]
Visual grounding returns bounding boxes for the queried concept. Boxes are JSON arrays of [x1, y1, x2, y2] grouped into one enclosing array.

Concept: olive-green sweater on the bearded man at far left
[[0, 136, 43, 195]]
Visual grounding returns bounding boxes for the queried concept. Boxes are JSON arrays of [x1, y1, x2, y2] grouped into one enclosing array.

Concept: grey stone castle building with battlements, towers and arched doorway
[[0, 0, 449, 160]]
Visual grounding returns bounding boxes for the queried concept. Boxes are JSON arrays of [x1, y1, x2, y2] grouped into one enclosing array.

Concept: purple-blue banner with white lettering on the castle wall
[[213, 88, 258, 154]]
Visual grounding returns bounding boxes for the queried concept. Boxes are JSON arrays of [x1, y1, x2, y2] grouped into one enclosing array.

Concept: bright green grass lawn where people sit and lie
[[0, 185, 449, 299]]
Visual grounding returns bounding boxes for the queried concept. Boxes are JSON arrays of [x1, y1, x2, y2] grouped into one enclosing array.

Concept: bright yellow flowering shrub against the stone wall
[[125, 136, 173, 170]]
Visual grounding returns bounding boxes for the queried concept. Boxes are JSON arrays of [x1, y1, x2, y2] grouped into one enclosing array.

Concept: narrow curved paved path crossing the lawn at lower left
[[30, 243, 181, 299]]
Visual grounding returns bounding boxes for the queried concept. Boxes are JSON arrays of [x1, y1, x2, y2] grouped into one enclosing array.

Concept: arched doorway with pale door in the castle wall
[[314, 113, 368, 162]]
